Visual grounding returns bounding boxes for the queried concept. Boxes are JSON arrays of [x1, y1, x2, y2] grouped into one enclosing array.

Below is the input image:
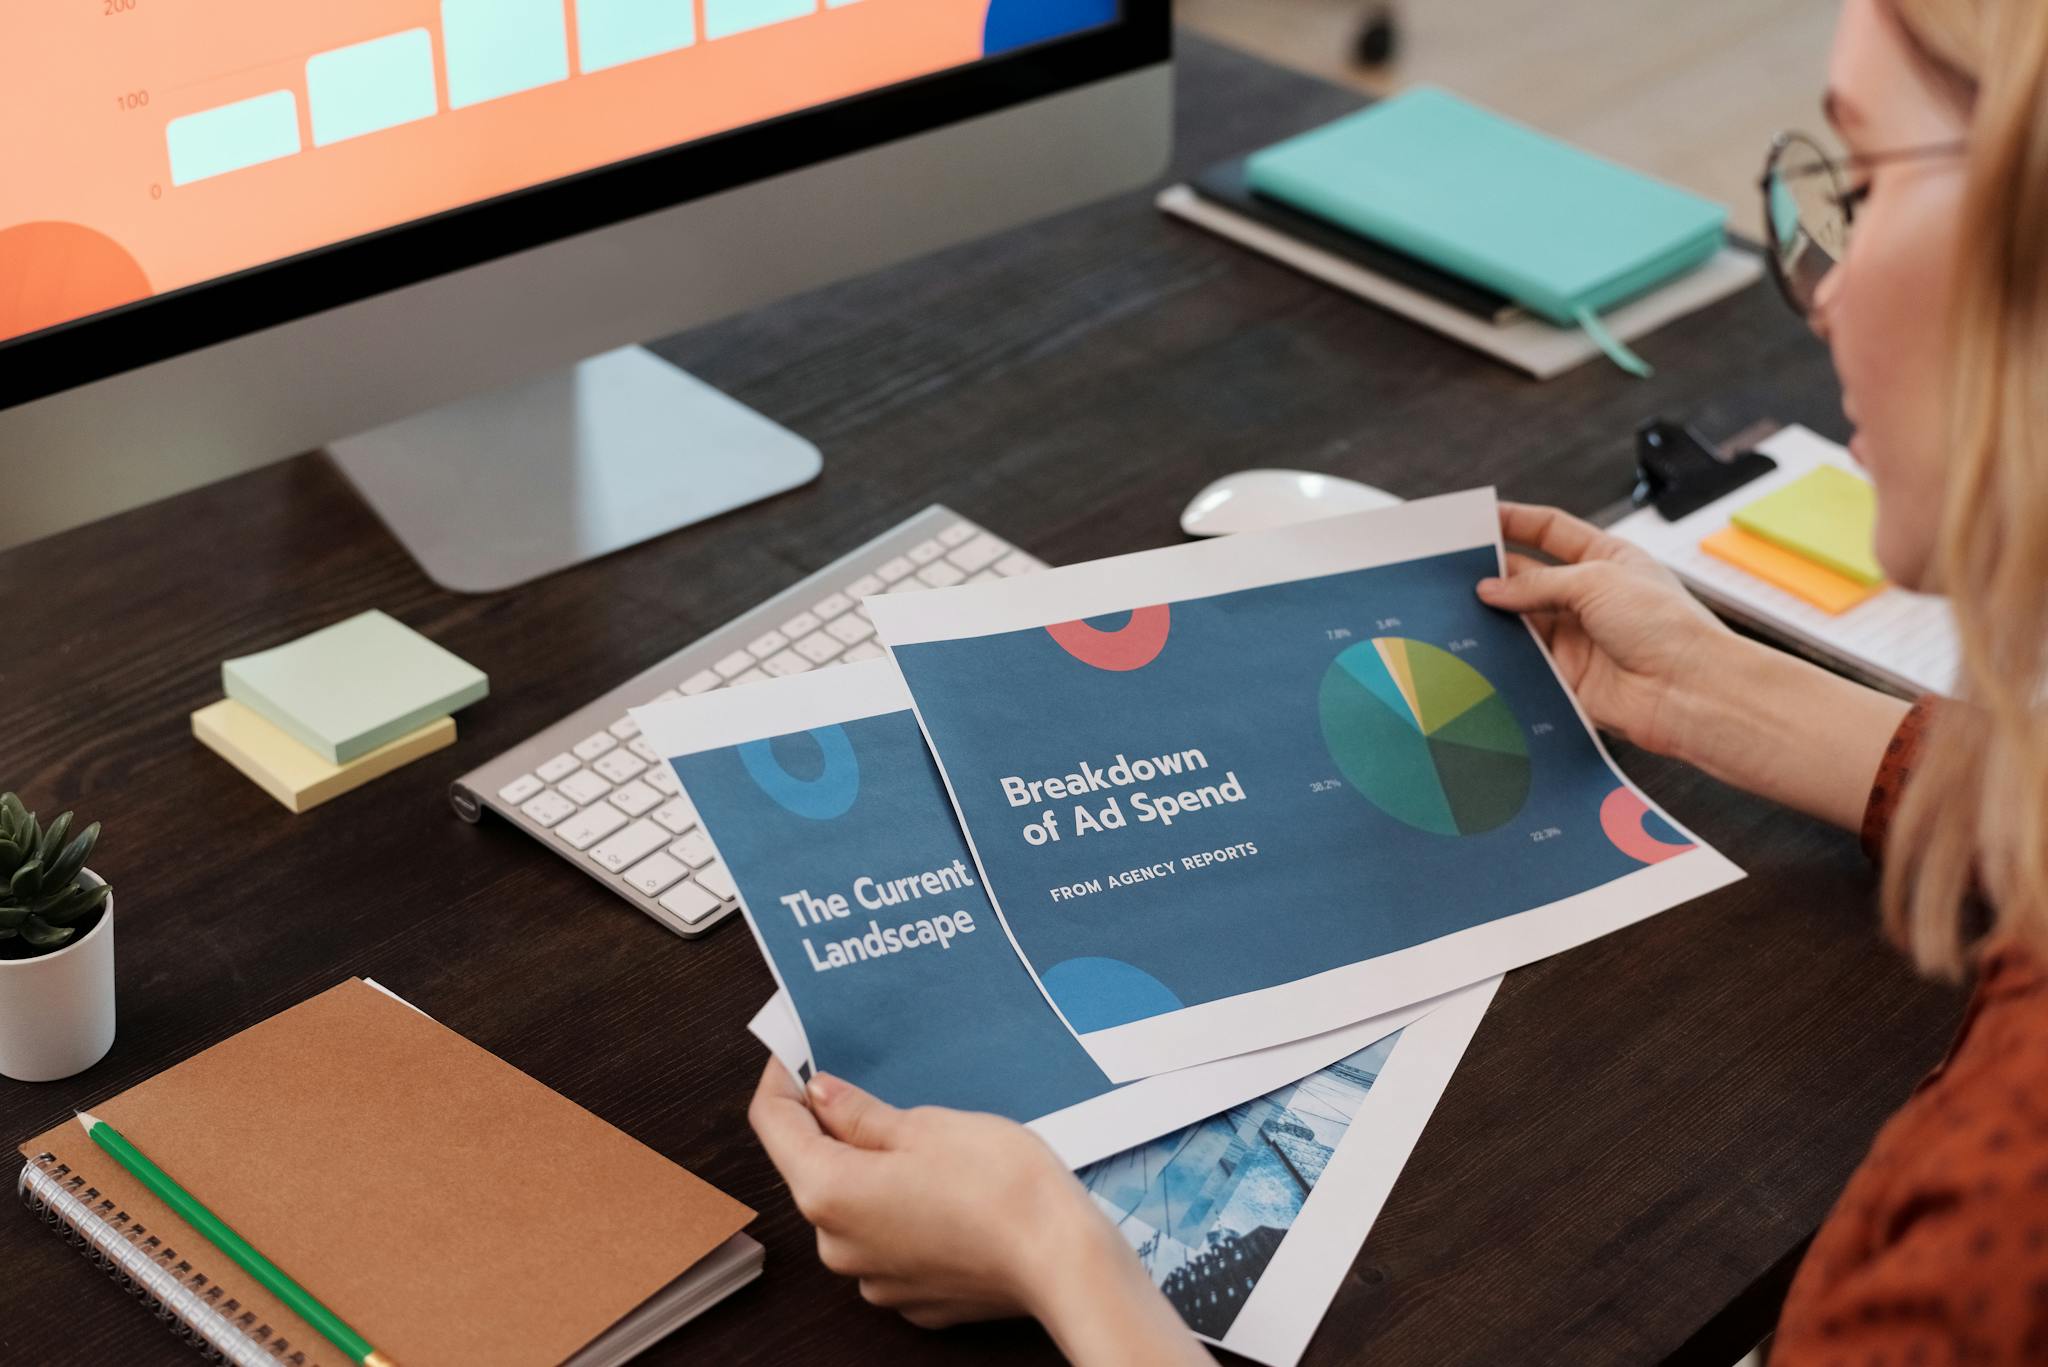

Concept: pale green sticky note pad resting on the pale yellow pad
[[221, 611, 489, 764]]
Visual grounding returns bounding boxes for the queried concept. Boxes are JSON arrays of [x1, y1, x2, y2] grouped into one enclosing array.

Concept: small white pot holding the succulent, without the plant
[[0, 869, 115, 1082]]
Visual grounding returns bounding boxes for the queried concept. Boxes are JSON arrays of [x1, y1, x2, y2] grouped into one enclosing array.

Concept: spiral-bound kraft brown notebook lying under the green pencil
[[20, 980, 762, 1367]]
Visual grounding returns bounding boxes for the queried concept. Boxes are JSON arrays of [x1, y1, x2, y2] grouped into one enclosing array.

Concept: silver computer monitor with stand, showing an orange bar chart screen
[[0, 0, 1171, 590]]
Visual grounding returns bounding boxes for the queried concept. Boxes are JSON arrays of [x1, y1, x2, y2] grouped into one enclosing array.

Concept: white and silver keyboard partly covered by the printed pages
[[449, 504, 1044, 937]]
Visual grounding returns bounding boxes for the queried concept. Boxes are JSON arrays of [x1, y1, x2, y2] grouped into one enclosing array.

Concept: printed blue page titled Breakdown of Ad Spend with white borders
[[870, 490, 1739, 1078]]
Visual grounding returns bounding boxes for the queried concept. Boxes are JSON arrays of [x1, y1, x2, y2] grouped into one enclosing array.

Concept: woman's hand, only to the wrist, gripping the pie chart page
[[1479, 502, 1741, 758]]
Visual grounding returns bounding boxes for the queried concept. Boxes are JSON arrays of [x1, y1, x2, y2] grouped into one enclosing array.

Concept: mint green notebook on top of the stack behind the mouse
[[1245, 86, 1729, 356]]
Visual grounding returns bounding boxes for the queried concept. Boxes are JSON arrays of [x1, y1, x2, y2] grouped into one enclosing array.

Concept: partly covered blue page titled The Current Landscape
[[633, 660, 1421, 1164]]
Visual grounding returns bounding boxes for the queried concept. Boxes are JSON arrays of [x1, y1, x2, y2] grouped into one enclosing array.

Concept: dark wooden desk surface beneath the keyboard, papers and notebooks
[[0, 39, 1958, 1367]]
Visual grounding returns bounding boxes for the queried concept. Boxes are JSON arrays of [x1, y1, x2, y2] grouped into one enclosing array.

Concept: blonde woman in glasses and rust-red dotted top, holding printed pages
[[752, 0, 2048, 1367]]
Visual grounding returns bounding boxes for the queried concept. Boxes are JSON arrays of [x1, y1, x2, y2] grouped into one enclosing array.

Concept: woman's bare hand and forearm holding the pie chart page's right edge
[[1479, 502, 1907, 830]]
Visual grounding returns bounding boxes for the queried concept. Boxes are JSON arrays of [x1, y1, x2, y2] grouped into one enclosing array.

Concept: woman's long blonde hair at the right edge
[[1884, 0, 2048, 978]]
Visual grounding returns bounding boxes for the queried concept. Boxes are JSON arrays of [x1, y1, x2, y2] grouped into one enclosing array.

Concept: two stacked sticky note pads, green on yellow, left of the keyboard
[[193, 611, 489, 812]]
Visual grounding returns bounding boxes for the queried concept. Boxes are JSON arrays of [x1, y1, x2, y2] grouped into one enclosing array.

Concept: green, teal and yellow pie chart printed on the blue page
[[1317, 635, 1530, 836]]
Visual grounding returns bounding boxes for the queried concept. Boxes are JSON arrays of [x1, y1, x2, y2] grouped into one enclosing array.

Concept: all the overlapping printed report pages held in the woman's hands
[[635, 490, 1741, 1367]]
